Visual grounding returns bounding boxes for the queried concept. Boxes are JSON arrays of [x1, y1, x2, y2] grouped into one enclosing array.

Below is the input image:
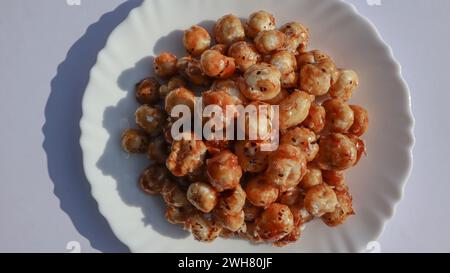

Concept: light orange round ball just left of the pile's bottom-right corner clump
[[305, 183, 338, 217]]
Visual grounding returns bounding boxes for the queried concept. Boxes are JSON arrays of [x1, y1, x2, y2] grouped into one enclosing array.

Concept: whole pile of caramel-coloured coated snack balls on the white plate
[[122, 11, 368, 246]]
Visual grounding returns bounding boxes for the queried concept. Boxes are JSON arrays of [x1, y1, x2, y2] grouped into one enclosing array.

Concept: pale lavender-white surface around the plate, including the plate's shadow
[[0, 0, 450, 252]]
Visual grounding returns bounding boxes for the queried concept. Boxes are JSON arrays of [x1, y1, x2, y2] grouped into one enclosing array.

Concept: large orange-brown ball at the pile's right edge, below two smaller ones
[[316, 133, 357, 171]]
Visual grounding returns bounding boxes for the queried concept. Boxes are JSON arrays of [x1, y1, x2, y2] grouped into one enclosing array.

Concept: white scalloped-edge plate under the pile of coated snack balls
[[80, 0, 414, 252]]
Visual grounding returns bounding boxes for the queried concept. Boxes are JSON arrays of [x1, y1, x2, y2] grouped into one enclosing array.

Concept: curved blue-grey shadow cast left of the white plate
[[42, 0, 143, 252]]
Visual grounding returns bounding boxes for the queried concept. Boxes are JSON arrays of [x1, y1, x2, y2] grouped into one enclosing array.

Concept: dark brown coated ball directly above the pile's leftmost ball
[[135, 104, 165, 136]]
